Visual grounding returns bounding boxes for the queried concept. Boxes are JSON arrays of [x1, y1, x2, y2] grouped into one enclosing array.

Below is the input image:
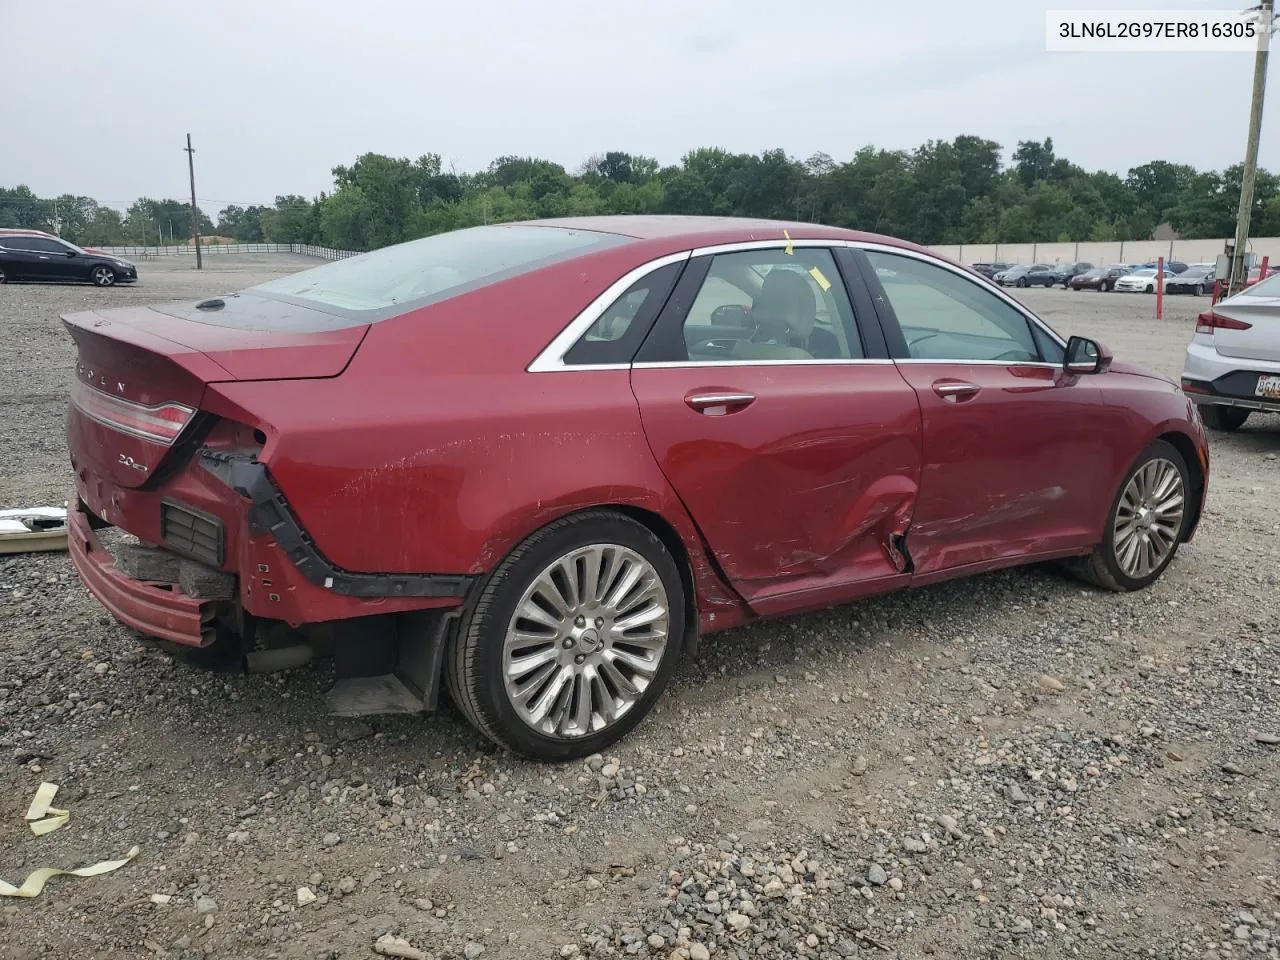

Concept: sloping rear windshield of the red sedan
[[246, 224, 628, 320]]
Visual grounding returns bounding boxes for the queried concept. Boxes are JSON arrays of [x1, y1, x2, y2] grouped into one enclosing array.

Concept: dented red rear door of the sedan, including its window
[[631, 244, 920, 614]]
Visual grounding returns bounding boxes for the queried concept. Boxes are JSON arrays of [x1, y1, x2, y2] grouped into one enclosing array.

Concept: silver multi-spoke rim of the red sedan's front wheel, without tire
[[1112, 458, 1187, 580]]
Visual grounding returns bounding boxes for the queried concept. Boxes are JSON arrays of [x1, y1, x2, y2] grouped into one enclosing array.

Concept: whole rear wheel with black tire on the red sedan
[[445, 509, 686, 762]]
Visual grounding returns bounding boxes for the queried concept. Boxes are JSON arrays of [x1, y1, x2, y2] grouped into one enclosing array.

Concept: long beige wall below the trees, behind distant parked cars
[[931, 237, 1280, 266]]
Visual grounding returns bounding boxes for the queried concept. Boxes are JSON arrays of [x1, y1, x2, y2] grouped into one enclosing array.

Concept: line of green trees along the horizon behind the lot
[[0, 136, 1280, 256]]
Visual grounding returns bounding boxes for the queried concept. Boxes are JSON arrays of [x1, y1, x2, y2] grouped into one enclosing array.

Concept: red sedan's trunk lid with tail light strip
[[63, 294, 369, 488]]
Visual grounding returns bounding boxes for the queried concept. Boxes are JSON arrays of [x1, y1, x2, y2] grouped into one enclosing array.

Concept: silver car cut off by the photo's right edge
[[1181, 274, 1280, 430]]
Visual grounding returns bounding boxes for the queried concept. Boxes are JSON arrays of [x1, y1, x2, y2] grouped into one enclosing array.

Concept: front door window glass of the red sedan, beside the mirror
[[867, 251, 1041, 364]]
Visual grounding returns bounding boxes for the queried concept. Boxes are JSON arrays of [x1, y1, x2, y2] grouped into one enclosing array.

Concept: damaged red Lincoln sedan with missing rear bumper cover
[[64, 216, 1208, 760]]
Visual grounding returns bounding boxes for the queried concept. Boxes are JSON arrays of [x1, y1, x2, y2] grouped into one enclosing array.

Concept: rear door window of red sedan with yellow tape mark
[[684, 247, 864, 362]]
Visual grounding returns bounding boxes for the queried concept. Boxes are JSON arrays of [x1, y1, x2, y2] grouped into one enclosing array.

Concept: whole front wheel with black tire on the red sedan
[[1070, 440, 1192, 593]]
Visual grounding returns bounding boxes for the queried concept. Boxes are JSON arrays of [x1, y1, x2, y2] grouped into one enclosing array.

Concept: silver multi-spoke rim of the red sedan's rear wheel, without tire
[[502, 544, 671, 739]]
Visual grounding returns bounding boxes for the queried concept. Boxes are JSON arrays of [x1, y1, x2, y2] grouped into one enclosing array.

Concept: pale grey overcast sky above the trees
[[0, 0, 1280, 212]]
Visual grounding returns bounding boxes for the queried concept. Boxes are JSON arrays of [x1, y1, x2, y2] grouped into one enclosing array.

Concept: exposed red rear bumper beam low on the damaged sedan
[[67, 504, 219, 646]]
